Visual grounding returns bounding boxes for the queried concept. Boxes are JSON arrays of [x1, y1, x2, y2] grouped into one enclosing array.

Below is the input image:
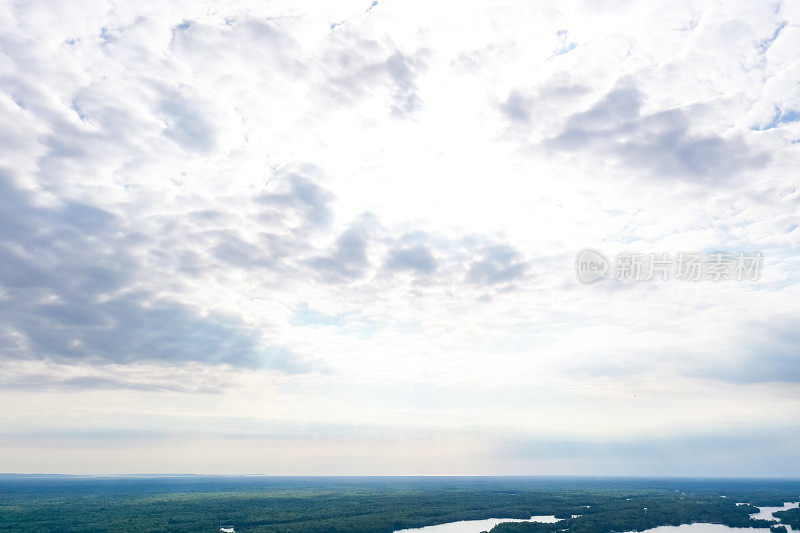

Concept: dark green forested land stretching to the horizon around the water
[[0, 476, 800, 533]]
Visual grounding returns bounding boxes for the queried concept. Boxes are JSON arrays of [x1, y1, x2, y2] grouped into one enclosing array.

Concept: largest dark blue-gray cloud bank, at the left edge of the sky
[[0, 176, 303, 372]]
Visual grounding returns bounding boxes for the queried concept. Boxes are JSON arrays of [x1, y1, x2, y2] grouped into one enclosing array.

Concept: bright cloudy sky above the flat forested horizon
[[0, 0, 800, 476]]
